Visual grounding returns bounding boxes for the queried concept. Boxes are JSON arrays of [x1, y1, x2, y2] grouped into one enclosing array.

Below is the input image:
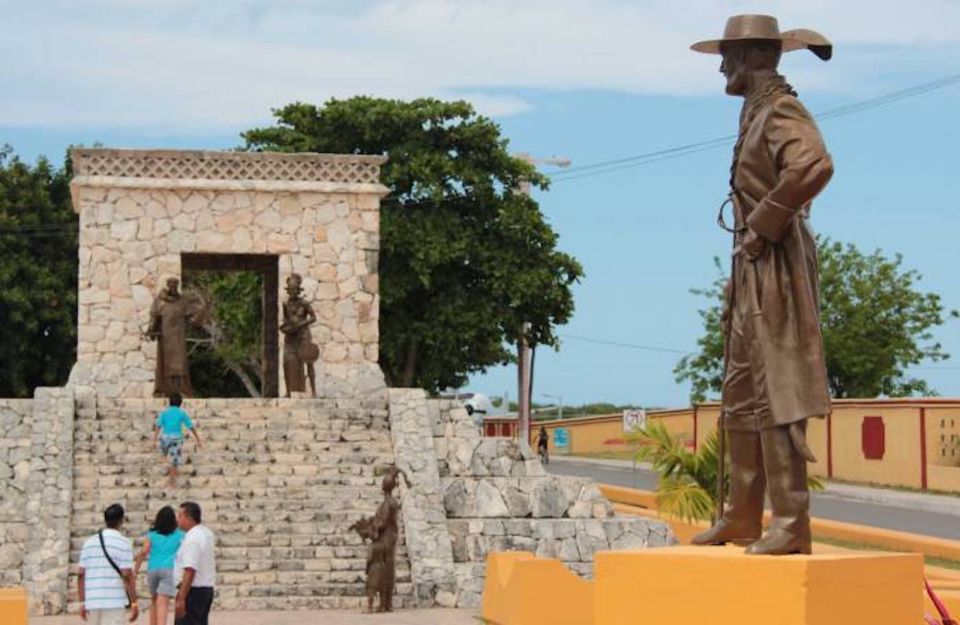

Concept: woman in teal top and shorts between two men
[[133, 506, 184, 625]]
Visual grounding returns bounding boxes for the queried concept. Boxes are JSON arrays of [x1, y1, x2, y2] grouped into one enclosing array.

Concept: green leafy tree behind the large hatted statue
[[674, 239, 958, 401]]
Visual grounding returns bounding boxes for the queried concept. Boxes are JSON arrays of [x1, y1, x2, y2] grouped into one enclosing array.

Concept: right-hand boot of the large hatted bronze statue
[[747, 421, 811, 555]]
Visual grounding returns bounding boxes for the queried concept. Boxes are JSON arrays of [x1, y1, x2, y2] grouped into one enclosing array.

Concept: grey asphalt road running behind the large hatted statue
[[548, 459, 960, 540]]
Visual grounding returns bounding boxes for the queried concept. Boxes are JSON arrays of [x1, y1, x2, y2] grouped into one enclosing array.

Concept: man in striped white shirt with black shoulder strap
[[77, 503, 138, 625]]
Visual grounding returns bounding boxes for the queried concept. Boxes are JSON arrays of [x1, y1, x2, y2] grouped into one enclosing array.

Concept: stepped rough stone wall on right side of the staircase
[[390, 389, 674, 607]]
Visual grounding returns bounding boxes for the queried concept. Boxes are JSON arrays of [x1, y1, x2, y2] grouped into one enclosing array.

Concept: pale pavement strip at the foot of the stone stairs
[[30, 608, 483, 625]]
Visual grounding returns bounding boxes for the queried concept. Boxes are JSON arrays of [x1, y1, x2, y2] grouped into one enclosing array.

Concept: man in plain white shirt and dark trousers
[[173, 501, 217, 625]]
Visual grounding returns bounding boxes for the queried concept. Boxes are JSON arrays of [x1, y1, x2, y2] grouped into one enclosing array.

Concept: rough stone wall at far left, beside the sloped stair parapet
[[0, 399, 33, 587]]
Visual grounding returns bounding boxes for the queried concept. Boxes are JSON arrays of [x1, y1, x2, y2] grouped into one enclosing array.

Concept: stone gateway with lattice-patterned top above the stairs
[[71, 149, 386, 398]]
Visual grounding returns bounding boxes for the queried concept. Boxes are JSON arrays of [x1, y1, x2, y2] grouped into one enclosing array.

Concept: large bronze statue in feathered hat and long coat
[[691, 15, 833, 554]]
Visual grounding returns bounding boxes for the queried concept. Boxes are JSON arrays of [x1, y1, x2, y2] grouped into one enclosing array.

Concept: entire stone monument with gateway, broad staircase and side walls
[[0, 149, 673, 614]]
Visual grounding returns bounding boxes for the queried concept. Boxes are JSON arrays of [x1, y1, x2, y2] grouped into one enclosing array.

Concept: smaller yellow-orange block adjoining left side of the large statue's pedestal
[[483, 551, 593, 625]]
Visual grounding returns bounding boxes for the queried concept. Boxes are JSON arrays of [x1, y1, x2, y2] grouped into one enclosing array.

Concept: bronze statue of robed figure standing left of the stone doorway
[[146, 278, 193, 397]]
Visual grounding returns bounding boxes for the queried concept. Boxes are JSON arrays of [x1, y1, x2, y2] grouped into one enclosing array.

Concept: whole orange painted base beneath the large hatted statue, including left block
[[483, 547, 928, 625]]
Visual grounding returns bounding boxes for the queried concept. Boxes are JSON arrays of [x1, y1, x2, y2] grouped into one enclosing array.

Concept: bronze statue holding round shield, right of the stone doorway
[[280, 273, 320, 397]]
